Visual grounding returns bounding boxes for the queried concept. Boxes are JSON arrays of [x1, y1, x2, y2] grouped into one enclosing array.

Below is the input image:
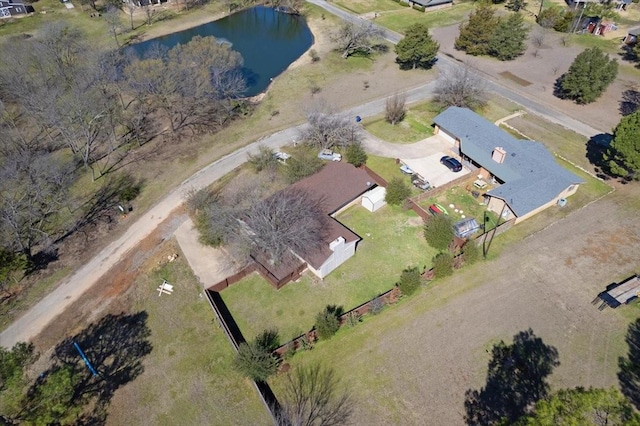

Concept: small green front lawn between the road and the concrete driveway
[[364, 102, 442, 143]]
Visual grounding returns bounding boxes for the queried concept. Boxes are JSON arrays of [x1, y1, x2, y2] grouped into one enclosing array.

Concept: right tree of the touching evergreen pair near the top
[[489, 13, 529, 61]]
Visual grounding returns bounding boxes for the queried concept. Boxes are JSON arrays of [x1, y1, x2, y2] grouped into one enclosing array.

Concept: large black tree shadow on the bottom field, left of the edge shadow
[[464, 329, 560, 426]]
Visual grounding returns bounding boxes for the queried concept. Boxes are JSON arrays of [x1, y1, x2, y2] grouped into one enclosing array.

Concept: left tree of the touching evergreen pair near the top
[[454, 4, 499, 55]]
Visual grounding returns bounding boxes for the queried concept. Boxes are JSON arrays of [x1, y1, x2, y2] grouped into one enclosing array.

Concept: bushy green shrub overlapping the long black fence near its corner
[[233, 329, 280, 381]]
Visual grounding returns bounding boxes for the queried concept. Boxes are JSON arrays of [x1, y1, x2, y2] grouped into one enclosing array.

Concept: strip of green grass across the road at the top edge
[[376, 3, 474, 33]]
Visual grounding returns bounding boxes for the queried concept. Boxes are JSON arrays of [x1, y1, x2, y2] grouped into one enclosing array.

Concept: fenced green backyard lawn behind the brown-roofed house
[[221, 206, 435, 341]]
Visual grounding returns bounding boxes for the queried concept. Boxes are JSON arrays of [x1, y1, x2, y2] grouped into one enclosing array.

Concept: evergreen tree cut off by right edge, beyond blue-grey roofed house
[[605, 110, 640, 178]]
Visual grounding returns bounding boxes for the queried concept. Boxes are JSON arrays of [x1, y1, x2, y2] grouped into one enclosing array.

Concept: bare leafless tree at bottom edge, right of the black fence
[[276, 365, 353, 426]]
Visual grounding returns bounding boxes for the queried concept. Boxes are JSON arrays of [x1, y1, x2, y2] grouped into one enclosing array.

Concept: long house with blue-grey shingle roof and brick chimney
[[433, 107, 583, 223]]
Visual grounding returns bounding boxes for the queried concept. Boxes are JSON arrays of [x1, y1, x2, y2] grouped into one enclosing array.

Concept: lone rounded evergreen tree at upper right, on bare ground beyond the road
[[559, 47, 618, 104]]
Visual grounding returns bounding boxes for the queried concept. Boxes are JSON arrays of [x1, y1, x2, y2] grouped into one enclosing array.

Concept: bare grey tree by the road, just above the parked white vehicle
[[300, 102, 362, 148]]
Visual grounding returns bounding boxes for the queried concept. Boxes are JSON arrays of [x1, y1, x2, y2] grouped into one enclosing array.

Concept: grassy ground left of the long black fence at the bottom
[[107, 241, 270, 425]]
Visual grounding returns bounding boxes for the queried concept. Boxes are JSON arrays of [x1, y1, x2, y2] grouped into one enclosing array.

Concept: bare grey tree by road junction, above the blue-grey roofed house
[[434, 64, 486, 108]]
